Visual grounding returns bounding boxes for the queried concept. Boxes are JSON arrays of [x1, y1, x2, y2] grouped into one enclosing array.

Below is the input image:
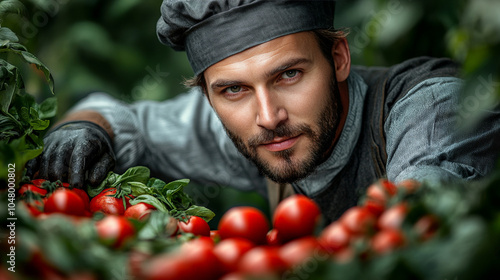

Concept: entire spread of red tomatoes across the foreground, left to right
[[15, 179, 439, 280]]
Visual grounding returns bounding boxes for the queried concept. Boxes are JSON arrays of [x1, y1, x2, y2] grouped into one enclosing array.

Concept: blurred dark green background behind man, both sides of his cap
[[2, 0, 500, 225]]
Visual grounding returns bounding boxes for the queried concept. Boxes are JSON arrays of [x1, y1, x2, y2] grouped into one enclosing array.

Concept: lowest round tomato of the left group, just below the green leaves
[[95, 215, 135, 248]]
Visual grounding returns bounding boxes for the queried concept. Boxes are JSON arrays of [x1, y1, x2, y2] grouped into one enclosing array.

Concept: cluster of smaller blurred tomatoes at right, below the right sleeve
[[318, 179, 439, 261]]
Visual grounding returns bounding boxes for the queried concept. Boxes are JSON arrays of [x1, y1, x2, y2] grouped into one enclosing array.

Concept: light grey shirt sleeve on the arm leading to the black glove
[[72, 89, 266, 194]]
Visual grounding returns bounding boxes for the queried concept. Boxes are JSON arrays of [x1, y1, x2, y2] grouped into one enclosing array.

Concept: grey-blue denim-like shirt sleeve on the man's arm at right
[[384, 77, 500, 185]]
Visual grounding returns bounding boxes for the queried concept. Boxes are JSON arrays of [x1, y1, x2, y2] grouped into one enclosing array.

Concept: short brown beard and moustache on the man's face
[[224, 75, 342, 183]]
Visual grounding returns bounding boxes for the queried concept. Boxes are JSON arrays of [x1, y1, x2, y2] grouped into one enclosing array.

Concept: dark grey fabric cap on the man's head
[[156, 0, 335, 75]]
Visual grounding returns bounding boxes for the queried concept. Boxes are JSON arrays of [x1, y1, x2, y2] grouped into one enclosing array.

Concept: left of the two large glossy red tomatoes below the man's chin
[[218, 206, 269, 245]]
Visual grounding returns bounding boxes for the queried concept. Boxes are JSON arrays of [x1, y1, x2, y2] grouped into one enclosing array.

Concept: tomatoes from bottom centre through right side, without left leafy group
[[134, 179, 438, 280]]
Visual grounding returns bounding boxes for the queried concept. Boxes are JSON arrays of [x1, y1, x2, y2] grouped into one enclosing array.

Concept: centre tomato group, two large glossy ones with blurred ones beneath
[[136, 195, 320, 279]]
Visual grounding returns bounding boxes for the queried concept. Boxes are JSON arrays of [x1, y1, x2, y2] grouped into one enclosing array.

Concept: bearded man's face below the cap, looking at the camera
[[205, 32, 339, 183]]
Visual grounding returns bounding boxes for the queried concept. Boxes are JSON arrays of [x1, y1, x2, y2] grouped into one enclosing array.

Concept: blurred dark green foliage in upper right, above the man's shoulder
[[336, 0, 500, 129]]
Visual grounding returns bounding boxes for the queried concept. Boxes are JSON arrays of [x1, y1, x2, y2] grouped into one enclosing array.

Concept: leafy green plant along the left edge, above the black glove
[[0, 1, 57, 180]]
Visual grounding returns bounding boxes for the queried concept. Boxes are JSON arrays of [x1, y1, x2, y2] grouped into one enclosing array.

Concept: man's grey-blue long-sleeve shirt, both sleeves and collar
[[69, 60, 500, 222]]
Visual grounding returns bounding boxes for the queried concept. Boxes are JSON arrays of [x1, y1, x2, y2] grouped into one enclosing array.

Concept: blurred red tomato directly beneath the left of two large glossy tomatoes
[[214, 238, 255, 273]]
